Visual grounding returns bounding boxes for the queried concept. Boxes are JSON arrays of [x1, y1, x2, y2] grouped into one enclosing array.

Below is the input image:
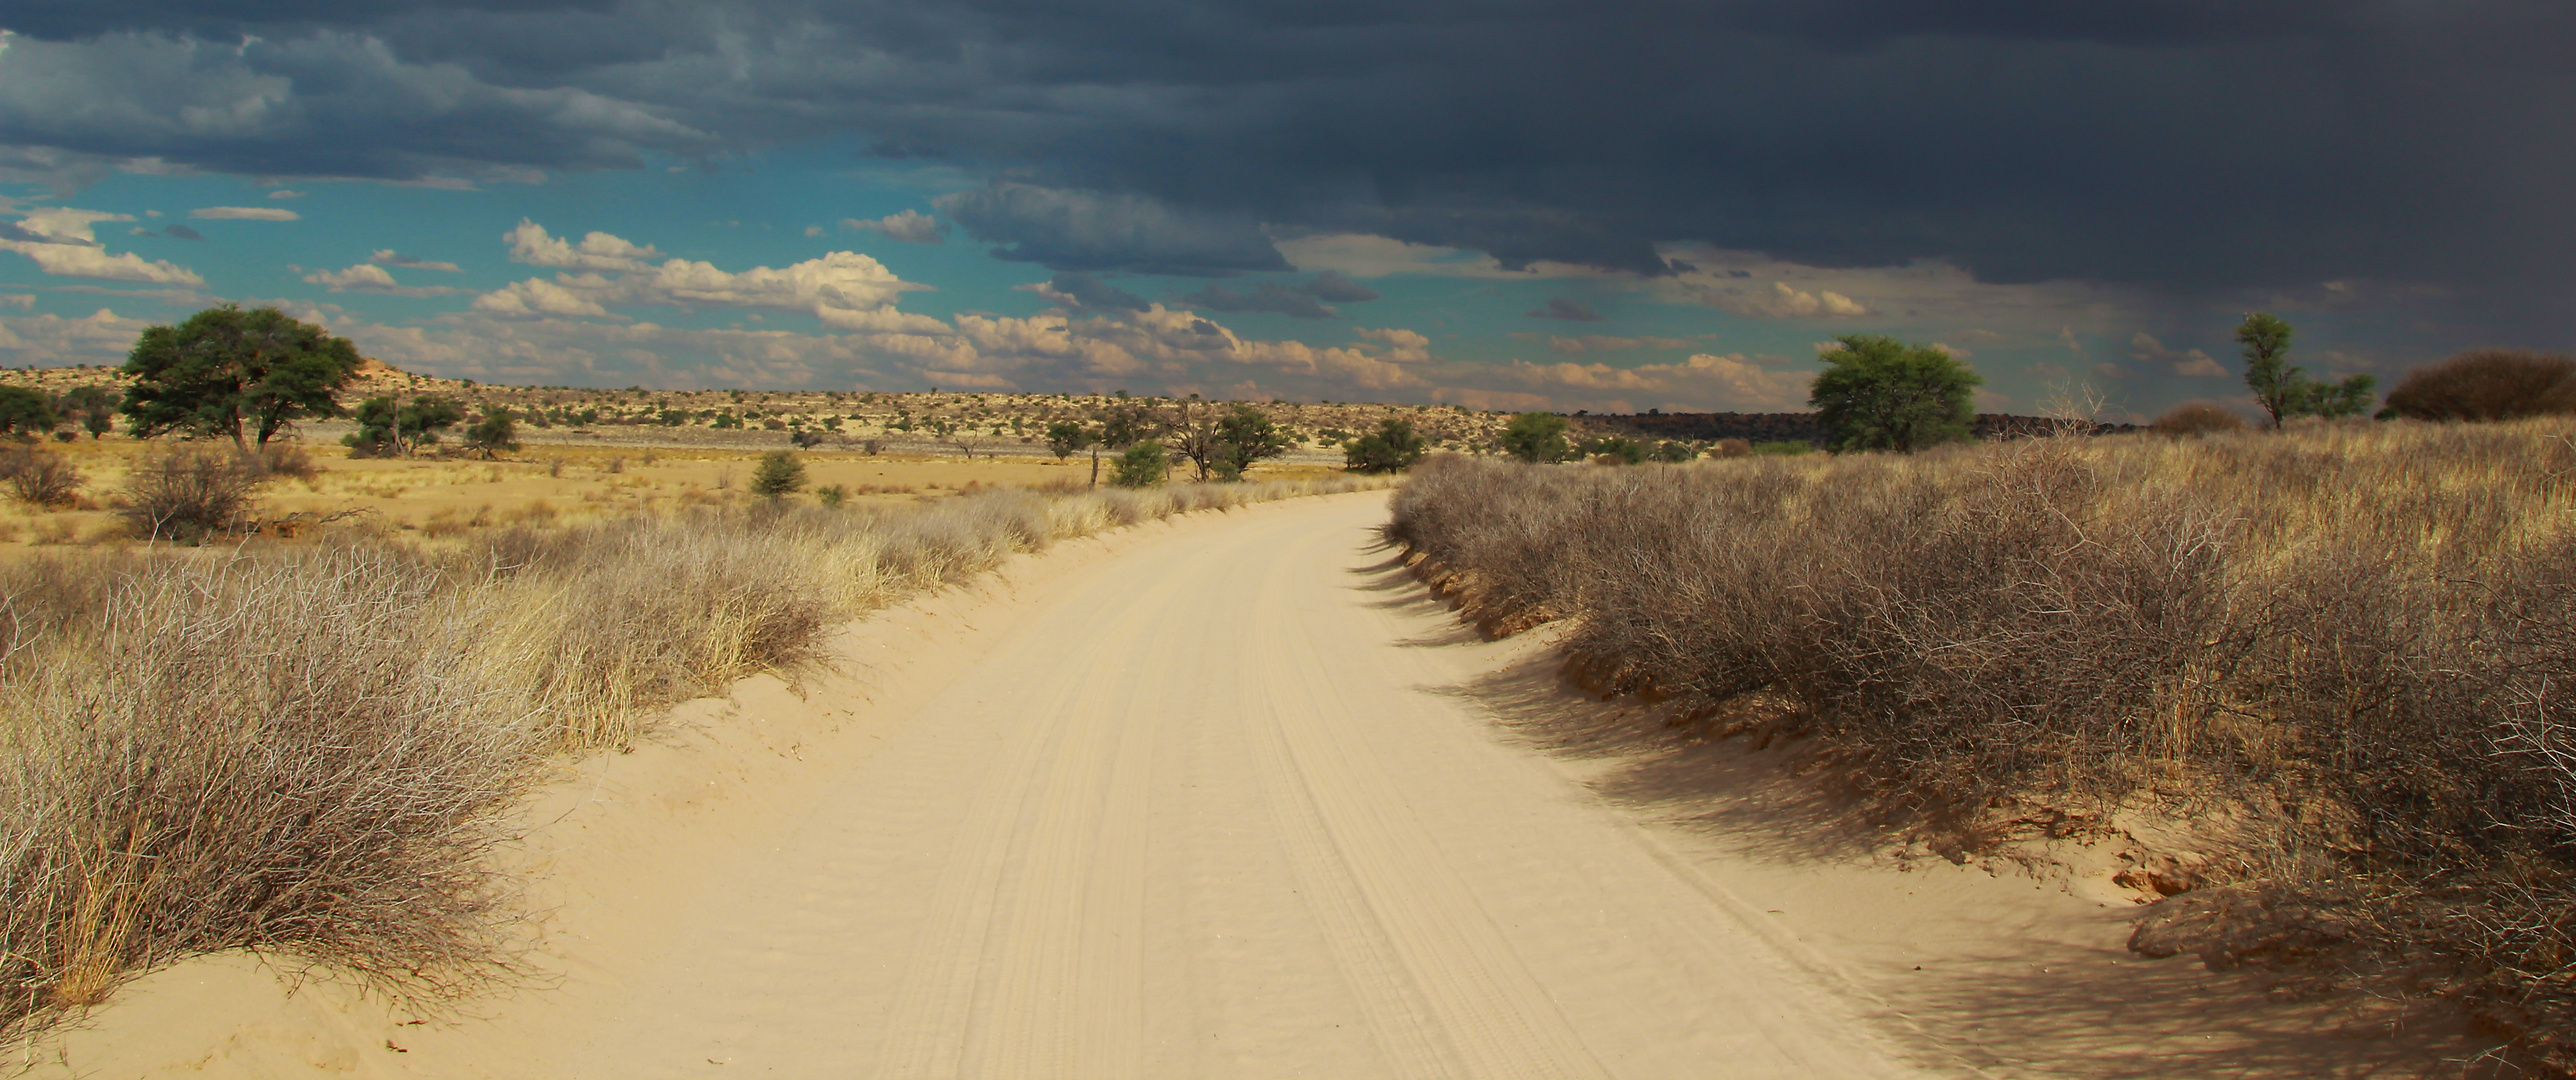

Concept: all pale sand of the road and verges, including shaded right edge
[[10, 492, 2483, 1077]]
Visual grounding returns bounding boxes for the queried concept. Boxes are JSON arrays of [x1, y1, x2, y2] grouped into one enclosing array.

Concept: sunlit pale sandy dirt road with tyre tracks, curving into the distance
[[45, 495, 1909, 1077]]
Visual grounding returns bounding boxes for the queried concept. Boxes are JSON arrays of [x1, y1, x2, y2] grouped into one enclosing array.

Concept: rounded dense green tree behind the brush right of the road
[[1806, 335, 1986, 454]]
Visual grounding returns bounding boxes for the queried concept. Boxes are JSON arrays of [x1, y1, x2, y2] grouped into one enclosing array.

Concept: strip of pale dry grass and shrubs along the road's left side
[[0, 471, 1383, 1039]]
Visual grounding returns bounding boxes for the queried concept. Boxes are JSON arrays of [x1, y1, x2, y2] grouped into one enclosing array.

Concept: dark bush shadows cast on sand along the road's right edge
[[1352, 559, 2524, 1080]]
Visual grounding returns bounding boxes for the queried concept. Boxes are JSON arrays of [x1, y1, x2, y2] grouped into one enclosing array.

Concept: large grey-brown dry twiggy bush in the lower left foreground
[[0, 552, 538, 1034]]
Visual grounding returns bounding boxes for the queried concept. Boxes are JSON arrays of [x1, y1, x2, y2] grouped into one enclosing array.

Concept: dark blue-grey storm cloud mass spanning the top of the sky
[[15, 0, 2576, 330]]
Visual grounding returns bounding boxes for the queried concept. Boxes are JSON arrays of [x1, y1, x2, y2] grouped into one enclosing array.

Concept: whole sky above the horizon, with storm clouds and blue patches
[[0, 0, 2576, 420]]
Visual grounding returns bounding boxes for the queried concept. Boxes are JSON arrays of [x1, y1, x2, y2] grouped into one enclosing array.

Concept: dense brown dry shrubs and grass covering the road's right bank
[[1388, 420, 2576, 1065]]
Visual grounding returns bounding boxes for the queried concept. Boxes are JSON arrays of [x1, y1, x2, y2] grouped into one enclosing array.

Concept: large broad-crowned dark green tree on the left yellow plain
[[124, 304, 358, 454]]
